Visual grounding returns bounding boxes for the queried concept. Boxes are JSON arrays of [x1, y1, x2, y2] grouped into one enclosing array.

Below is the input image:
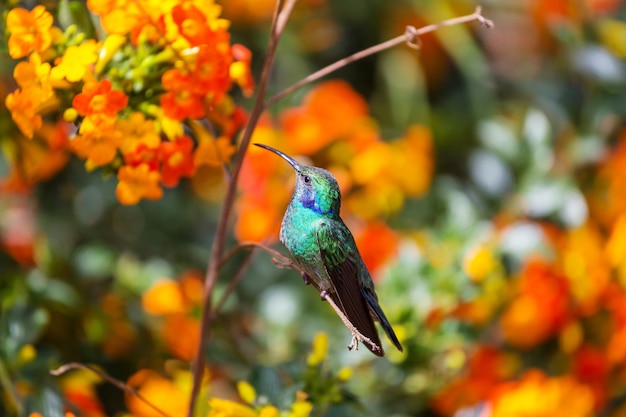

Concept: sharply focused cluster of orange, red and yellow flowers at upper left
[[5, 0, 254, 204]]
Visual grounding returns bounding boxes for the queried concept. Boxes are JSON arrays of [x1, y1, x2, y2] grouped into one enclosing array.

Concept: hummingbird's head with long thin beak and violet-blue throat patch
[[255, 143, 341, 217]]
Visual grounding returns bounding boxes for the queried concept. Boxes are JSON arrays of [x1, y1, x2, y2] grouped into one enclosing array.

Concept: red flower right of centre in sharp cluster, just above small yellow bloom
[[161, 69, 204, 120]]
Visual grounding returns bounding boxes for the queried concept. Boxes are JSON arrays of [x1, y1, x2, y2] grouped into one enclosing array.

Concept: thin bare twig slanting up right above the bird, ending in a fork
[[265, 6, 493, 108]]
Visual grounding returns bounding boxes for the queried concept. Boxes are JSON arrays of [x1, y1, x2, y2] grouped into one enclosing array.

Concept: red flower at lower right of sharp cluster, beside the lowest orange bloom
[[160, 136, 196, 187]]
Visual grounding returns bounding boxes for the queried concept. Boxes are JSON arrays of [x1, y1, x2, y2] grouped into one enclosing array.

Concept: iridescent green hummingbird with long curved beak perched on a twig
[[255, 143, 402, 356]]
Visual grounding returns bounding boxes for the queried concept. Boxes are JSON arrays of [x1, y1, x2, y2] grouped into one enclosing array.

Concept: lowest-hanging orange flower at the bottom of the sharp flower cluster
[[115, 164, 163, 205]]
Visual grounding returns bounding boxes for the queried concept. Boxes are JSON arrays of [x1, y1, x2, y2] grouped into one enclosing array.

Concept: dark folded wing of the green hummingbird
[[317, 220, 384, 356]]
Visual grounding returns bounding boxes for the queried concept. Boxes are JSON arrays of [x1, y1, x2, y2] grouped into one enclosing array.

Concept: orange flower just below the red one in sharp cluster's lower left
[[70, 129, 123, 166]]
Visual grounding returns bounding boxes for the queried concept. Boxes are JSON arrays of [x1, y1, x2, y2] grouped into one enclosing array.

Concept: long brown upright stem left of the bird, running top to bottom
[[187, 0, 296, 417]]
